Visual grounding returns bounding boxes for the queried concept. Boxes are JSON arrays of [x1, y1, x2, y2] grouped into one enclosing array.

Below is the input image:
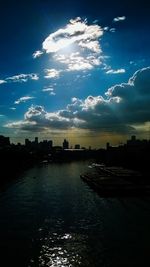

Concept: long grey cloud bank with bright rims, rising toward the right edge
[[6, 67, 150, 133]]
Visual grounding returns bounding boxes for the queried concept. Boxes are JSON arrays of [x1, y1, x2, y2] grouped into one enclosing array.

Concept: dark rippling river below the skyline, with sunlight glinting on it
[[0, 161, 150, 267]]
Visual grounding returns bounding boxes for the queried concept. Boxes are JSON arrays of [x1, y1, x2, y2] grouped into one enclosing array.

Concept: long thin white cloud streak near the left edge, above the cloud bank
[[6, 73, 39, 82]]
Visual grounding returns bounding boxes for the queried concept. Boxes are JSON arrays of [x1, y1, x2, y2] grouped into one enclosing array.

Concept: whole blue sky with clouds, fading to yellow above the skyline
[[0, 0, 150, 148]]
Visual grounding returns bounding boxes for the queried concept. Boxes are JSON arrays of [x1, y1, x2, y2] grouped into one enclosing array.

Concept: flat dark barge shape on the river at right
[[80, 165, 150, 196]]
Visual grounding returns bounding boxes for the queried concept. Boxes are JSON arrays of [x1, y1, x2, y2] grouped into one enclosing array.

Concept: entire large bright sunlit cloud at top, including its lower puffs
[[35, 17, 104, 71]]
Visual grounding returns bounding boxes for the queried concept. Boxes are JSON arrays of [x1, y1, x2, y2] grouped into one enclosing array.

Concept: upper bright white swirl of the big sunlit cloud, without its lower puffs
[[42, 18, 103, 53]]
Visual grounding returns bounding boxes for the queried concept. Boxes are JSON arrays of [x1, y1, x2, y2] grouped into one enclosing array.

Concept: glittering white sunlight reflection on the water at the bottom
[[31, 232, 86, 267]]
